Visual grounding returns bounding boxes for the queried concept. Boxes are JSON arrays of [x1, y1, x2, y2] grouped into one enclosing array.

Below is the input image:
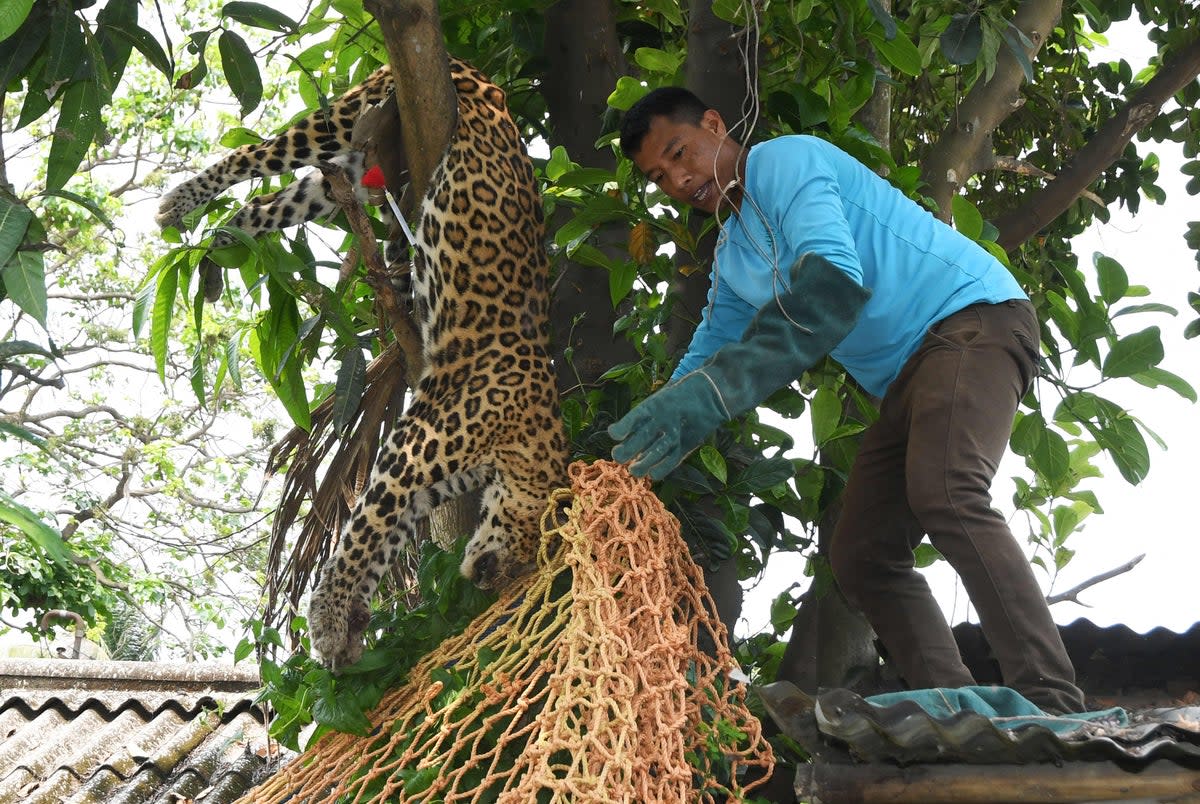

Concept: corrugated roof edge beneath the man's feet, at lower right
[[756, 682, 1200, 804]]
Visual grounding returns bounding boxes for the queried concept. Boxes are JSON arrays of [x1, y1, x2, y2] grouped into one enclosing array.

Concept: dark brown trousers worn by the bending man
[[830, 300, 1084, 713]]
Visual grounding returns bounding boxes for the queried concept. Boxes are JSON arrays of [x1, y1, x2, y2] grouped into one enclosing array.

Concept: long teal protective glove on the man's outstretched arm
[[608, 253, 871, 480]]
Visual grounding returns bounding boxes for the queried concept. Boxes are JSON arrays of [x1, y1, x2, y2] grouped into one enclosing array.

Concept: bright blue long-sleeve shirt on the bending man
[[671, 134, 1026, 396]]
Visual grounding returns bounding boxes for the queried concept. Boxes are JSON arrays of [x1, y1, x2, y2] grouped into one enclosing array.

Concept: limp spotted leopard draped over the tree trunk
[[158, 58, 569, 671]]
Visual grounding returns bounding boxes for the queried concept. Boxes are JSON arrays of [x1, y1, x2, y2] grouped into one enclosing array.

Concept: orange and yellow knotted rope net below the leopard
[[242, 462, 774, 804]]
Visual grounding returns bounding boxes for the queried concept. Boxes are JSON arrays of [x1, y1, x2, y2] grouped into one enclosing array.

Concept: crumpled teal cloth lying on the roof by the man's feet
[[864, 686, 1129, 736]]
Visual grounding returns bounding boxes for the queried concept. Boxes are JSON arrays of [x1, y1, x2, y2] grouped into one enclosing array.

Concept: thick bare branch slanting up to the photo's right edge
[[994, 37, 1200, 251]]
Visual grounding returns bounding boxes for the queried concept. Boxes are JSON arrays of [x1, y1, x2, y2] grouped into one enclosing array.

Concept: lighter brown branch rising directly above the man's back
[[922, 0, 1062, 221]]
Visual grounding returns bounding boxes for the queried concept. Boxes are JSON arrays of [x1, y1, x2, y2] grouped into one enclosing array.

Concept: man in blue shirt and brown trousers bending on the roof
[[610, 88, 1084, 713]]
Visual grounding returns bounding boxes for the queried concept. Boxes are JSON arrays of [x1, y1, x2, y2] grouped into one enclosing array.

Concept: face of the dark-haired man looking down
[[632, 109, 742, 214]]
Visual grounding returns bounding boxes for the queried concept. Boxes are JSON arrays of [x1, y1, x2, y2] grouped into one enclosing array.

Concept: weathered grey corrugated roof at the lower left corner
[[0, 659, 288, 804]]
